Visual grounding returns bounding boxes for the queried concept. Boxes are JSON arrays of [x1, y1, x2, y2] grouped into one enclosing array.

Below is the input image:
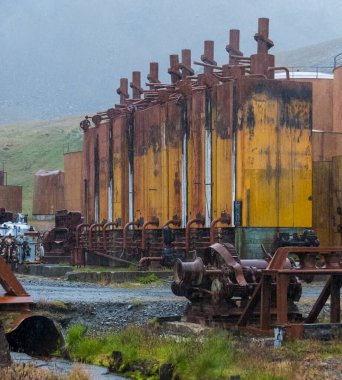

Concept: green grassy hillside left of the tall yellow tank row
[[0, 117, 83, 215]]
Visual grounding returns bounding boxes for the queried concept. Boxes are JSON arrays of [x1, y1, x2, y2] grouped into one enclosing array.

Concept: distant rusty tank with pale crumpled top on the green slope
[[32, 170, 64, 220]]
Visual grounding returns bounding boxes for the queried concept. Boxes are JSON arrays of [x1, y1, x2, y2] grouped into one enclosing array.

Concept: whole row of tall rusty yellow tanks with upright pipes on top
[[81, 19, 312, 262]]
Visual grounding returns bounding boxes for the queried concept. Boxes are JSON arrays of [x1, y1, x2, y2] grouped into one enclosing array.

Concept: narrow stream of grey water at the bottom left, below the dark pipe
[[11, 352, 127, 380]]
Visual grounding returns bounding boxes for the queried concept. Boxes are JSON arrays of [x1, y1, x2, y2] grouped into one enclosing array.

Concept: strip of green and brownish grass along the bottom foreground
[[66, 323, 342, 380]]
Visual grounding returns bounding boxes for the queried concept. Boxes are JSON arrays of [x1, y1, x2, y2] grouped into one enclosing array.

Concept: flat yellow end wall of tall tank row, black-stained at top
[[236, 79, 312, 227]]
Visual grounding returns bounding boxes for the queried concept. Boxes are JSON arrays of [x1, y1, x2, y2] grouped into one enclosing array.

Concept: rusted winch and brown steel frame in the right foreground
[[172, 239, 342, 338]]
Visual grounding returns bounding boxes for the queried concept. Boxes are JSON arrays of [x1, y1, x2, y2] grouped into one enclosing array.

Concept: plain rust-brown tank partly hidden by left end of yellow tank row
[[63, 152, 83, 211]]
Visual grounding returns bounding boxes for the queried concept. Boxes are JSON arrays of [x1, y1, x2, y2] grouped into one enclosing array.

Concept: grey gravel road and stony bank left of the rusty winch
[[18, 275, 188, 334]]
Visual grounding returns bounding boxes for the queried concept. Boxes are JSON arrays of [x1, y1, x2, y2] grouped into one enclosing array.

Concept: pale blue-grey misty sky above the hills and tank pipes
[[0, 0, 342, 124]]
